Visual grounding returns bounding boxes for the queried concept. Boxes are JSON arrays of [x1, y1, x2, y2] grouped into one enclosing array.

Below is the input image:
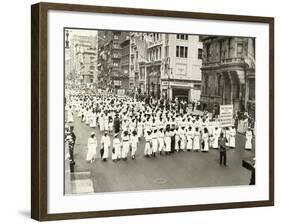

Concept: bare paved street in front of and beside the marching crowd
[[65, 112, 252, 194]]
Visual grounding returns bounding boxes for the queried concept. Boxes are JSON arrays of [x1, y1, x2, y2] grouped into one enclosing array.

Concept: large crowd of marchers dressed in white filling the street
[[65, 92, 253, 165]]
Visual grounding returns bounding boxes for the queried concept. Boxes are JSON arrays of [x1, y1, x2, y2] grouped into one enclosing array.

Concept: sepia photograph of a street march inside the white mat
[[62, 27, 256, 195]]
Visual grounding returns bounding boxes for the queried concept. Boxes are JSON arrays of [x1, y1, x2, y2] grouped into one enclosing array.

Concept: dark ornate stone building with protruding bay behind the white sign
[[198, 36, 255, 116]]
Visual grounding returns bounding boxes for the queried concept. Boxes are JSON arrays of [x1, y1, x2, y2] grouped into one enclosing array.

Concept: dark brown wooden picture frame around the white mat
[[31, 3, 274, 221]]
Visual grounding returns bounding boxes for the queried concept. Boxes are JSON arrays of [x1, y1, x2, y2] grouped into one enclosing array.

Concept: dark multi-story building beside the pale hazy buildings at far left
[[98, 31, 129, 89]]
